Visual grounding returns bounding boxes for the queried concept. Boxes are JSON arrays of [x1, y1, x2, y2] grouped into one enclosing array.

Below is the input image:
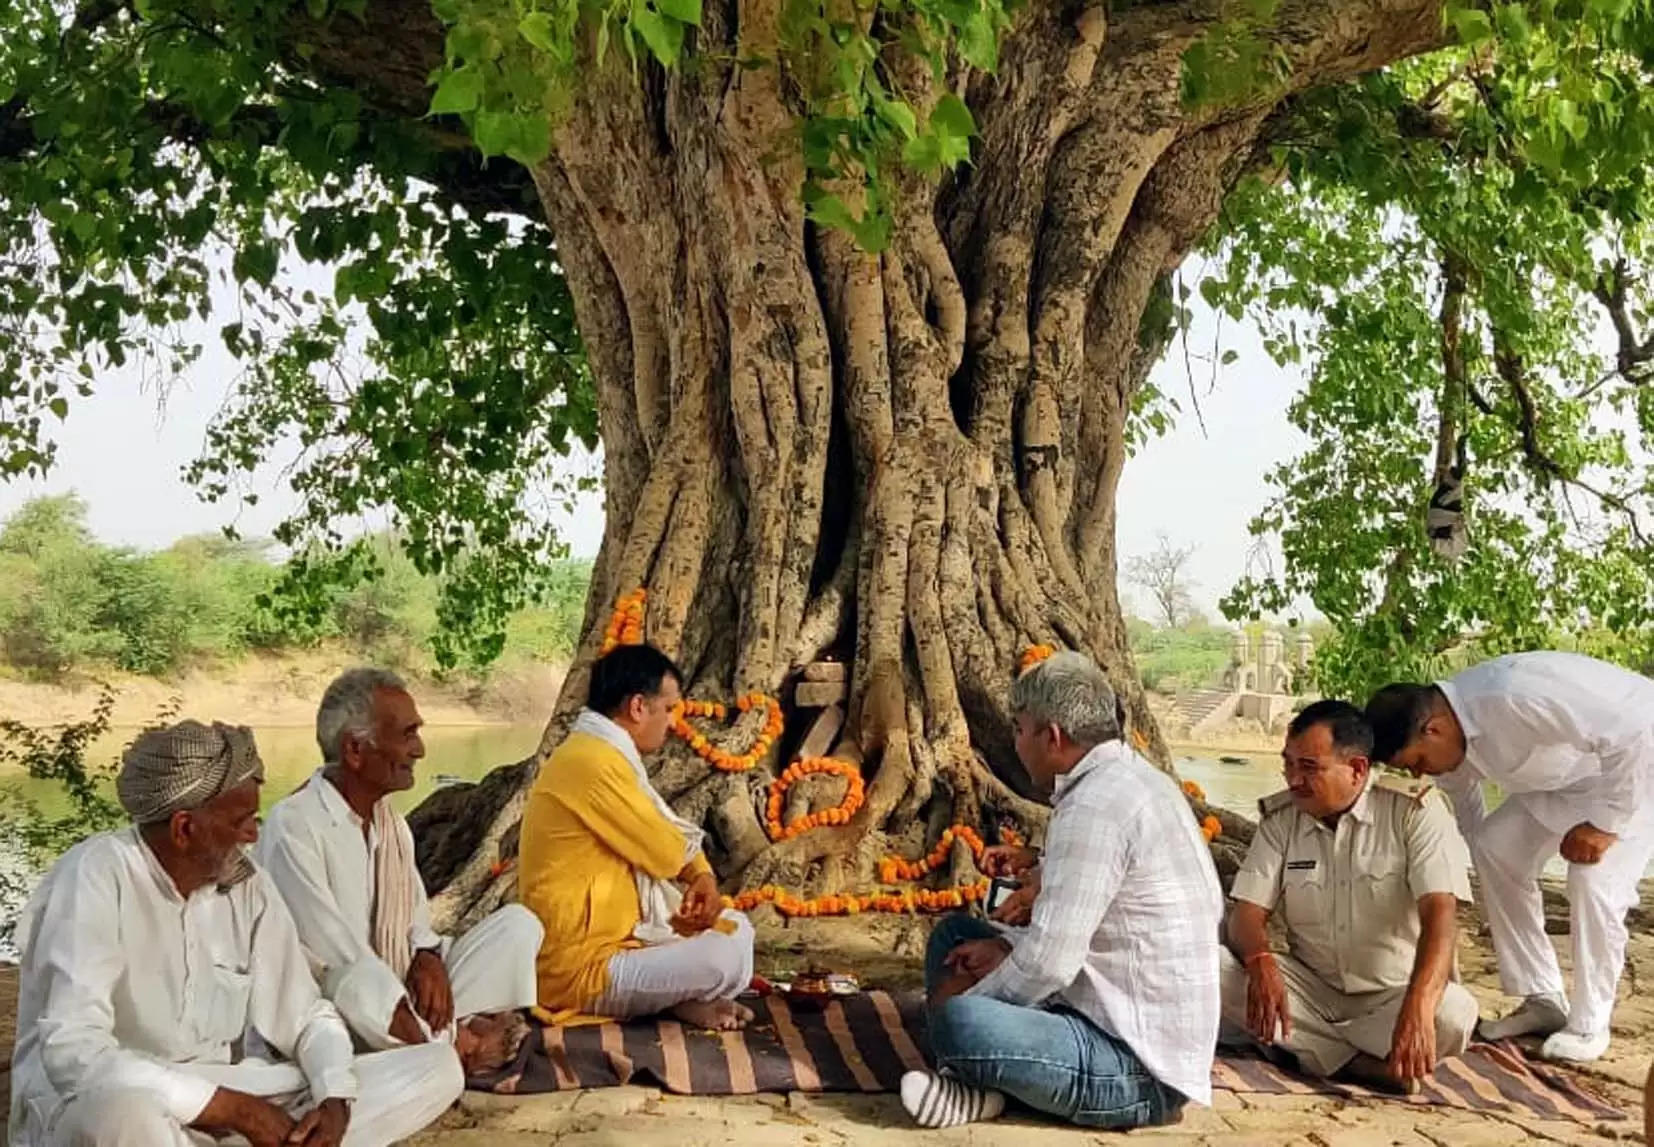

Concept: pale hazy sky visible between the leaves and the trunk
[[0, 283, 1300, 612]]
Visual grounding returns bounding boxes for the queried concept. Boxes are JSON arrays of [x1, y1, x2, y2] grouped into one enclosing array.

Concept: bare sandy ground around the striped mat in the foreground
[[0, 907, 1654, 1147]]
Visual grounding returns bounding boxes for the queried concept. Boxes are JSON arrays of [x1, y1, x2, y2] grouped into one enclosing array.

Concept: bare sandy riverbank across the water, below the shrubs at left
[[0, 650, 562, 727]]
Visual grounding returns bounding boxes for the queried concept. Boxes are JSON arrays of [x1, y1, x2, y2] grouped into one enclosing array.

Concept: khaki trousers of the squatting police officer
[[1219, 948, 1477, 1076]]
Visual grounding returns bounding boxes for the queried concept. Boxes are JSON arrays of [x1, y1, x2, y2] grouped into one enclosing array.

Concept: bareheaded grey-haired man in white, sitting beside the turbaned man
[[260, 669, 543, 1074]]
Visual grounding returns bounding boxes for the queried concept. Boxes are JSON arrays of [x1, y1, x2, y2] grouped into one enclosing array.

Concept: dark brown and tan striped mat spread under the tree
[[470, 991, 1626, 1122]]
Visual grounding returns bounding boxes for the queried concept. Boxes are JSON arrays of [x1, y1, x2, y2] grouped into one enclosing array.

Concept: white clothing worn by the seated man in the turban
[[10, 828, 463, 1147]]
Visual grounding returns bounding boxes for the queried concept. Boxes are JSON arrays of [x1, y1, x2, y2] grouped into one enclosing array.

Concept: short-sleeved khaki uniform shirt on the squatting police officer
[[1229, 780, 1470, 995]]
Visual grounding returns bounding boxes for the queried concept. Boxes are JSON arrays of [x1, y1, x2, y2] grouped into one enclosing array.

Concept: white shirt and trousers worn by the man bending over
[[1437, 652, 1654, 1034]]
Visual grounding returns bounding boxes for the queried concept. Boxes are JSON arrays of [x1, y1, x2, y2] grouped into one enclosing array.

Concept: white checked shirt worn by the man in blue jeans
[[971, 741, 1224, 1104]]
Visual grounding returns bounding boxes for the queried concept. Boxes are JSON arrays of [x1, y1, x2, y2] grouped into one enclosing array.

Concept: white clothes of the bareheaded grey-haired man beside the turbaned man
[[258, 770, 544, 1048]]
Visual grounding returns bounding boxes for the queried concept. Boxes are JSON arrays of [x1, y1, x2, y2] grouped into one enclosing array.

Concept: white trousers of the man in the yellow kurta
[[592, 912, 753, 1020]]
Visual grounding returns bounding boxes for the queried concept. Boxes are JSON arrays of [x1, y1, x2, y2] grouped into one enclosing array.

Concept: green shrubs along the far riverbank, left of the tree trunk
[[0, 495, 592, 680]]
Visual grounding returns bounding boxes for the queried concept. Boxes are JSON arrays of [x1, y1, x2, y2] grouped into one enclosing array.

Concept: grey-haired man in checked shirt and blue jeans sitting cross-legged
[[901, 654, 1224, 1130]]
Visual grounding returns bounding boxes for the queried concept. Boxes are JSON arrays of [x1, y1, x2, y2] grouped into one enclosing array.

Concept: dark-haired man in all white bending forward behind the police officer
[[1366, 652, 1654, 1061]]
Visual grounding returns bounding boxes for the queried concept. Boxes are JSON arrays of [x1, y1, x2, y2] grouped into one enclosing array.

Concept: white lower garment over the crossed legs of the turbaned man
[[45, 1043, 465, 1147]]
